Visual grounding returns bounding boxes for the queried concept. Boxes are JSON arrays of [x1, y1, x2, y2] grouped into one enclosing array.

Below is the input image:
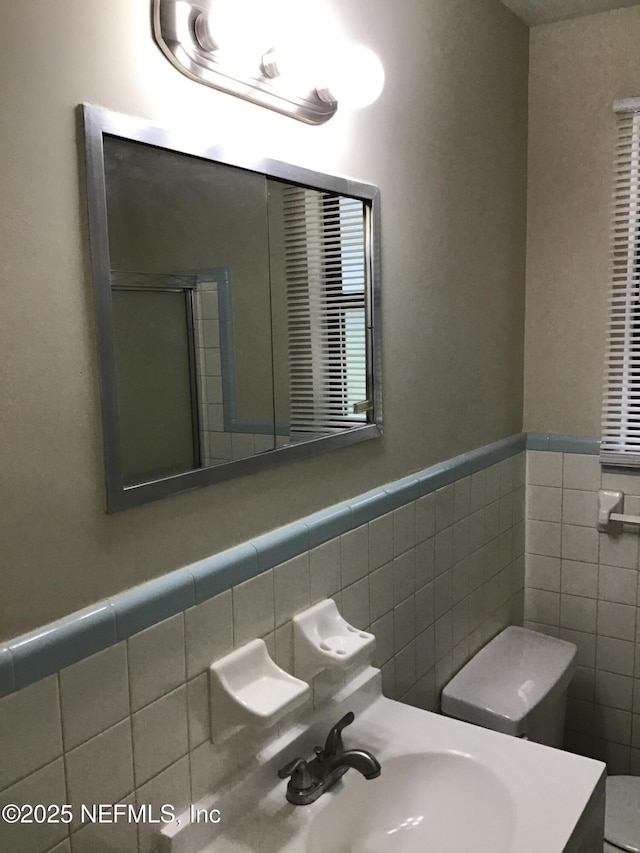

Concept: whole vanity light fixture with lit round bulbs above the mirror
[[152, 0, 384, 124]]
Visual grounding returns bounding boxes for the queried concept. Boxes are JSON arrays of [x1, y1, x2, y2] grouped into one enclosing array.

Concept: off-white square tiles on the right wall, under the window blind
[[525, 450, 640, 774]]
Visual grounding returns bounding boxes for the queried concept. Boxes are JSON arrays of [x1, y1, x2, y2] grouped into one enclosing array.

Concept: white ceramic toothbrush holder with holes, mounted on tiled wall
[[293, 598, 376, 681]]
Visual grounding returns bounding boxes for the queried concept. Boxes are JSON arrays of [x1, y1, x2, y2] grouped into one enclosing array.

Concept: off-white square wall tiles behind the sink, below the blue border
[[0, 452, 525, 853]]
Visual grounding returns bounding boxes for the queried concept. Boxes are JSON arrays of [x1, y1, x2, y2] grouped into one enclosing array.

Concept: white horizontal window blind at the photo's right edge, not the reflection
[[600, 105, 640, 467]]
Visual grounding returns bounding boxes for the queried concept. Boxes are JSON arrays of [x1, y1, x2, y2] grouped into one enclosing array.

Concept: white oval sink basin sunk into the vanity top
[[307, 752, 516, 853]]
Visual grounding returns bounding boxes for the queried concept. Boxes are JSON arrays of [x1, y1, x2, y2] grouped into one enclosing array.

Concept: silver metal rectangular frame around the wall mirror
[[79, 104, 382, 512]]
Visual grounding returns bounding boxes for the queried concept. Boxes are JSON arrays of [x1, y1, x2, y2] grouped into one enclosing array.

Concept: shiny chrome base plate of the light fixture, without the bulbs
[[153, 0, 338, 124]]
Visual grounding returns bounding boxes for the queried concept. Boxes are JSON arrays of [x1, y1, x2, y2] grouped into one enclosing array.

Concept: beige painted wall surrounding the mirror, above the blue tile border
[[0, 0, 528, 638]]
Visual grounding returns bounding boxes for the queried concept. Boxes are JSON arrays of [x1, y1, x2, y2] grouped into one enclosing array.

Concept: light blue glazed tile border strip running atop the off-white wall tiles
[[0, 434, 528, 696]]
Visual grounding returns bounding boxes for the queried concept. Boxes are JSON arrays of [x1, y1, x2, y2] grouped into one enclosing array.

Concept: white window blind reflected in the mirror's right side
[[283, 187, 367, 439]]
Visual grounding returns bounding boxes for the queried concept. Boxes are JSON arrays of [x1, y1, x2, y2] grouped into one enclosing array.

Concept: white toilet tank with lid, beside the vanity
[[441, 625, 577, 747]]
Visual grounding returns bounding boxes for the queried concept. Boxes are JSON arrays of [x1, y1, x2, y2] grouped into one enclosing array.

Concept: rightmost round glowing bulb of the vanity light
[[316, 44, 384, 108]]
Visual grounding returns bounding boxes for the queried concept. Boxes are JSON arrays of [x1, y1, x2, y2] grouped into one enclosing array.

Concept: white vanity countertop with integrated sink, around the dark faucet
[[160, 670, 605, 853]]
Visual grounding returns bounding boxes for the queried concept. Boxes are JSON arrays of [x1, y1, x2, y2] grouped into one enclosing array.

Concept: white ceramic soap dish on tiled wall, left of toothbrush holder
[[209, 640, 310, 742]]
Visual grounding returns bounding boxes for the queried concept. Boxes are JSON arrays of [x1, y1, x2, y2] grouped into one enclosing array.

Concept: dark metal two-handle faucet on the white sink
[[278, 711, 380, 806]]
